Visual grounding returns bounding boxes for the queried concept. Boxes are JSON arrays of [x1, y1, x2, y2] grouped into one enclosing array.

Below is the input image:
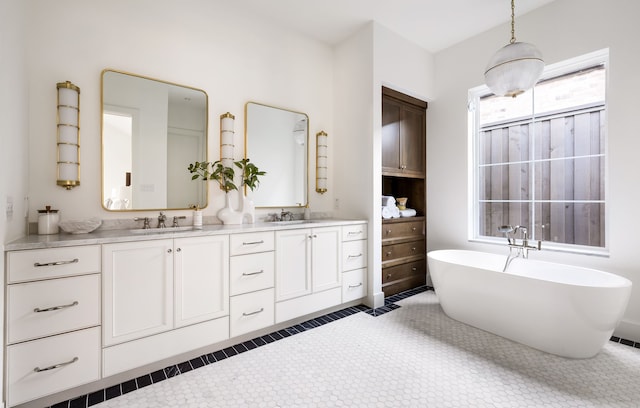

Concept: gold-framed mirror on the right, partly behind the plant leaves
[[245, 102, 309, 208]]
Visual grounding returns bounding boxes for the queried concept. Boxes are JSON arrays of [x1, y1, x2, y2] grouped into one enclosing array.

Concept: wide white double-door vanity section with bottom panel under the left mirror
[[102, 235, 229, 377]]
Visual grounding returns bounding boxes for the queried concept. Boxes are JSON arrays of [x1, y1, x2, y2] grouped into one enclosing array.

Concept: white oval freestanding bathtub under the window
[[427, 250, 631, 358]]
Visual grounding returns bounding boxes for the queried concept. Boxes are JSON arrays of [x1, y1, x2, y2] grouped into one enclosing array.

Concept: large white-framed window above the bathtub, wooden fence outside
[[469, 50, 608, 252]]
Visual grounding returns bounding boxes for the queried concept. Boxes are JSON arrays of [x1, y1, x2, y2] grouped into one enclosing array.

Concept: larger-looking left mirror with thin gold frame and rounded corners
[[102, 69, 208, 211]]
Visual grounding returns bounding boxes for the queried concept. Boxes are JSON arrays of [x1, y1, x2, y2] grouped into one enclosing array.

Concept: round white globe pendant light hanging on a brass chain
[[484, 0, 544, 98]]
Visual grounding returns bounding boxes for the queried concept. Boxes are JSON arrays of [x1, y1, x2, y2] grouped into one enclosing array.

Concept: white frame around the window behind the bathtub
[[467, 48, 611, 256]]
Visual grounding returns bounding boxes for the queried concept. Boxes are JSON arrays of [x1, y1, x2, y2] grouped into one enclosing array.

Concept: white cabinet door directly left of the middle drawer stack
[[174, 235, 229, 327]]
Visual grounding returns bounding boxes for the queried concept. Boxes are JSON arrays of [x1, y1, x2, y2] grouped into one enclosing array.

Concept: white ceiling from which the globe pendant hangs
[[233, 0, 554, 53]]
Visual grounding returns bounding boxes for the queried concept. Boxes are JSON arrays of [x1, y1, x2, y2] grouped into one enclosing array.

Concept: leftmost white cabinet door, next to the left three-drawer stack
[[102, 239, 173, 346]]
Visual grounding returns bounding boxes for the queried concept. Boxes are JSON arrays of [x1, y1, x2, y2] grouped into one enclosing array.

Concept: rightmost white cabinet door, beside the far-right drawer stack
[[311, 227, 342, 293]]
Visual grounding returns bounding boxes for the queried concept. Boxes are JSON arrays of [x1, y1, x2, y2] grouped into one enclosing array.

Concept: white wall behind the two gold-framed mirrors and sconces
[[26, 0, 333, 221]]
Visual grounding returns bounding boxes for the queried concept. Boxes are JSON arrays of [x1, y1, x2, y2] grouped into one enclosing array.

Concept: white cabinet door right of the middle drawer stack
[[276, 229, 311, 301]]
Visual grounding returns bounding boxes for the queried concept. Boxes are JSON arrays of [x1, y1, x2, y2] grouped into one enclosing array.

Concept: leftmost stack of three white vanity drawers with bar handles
[[6, 245, 101, 406]]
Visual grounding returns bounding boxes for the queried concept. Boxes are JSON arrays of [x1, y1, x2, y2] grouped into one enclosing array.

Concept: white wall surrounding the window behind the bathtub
[[427, 0, 640, 341]]
